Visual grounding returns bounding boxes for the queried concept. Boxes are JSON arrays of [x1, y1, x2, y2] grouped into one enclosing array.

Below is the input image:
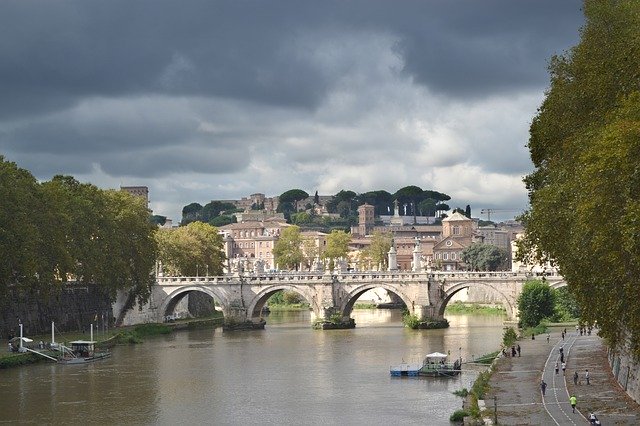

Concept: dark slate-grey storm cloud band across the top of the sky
[[0, 0, 581, 117]]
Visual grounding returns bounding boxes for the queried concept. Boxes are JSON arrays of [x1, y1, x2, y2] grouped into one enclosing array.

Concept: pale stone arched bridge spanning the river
[[120, 271, 566, 328]]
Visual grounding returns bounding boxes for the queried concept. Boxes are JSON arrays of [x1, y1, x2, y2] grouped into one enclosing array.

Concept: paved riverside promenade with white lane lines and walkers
[[485, 328, 640, 425]]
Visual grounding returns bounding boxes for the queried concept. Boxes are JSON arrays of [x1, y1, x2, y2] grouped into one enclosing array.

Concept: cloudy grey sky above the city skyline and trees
[[0, 0, 583, 223]]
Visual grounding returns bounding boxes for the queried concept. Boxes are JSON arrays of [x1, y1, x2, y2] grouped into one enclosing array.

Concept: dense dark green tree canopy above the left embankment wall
[[0, 156, 157, 301]]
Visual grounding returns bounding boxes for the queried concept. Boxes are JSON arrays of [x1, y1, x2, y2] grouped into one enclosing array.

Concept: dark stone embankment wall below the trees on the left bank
[[0, 283, 113, 339]]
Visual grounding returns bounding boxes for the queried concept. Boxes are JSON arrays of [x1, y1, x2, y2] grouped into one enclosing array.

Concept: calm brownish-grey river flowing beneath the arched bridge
[[0, 309, 503, 425]]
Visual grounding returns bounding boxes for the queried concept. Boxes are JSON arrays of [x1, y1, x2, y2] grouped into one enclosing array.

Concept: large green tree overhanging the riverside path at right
[[520, 0, 640, 353]]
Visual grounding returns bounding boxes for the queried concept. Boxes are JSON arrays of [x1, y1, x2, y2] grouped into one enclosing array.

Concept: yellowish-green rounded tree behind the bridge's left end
[[156, 221, 226, 276]]
